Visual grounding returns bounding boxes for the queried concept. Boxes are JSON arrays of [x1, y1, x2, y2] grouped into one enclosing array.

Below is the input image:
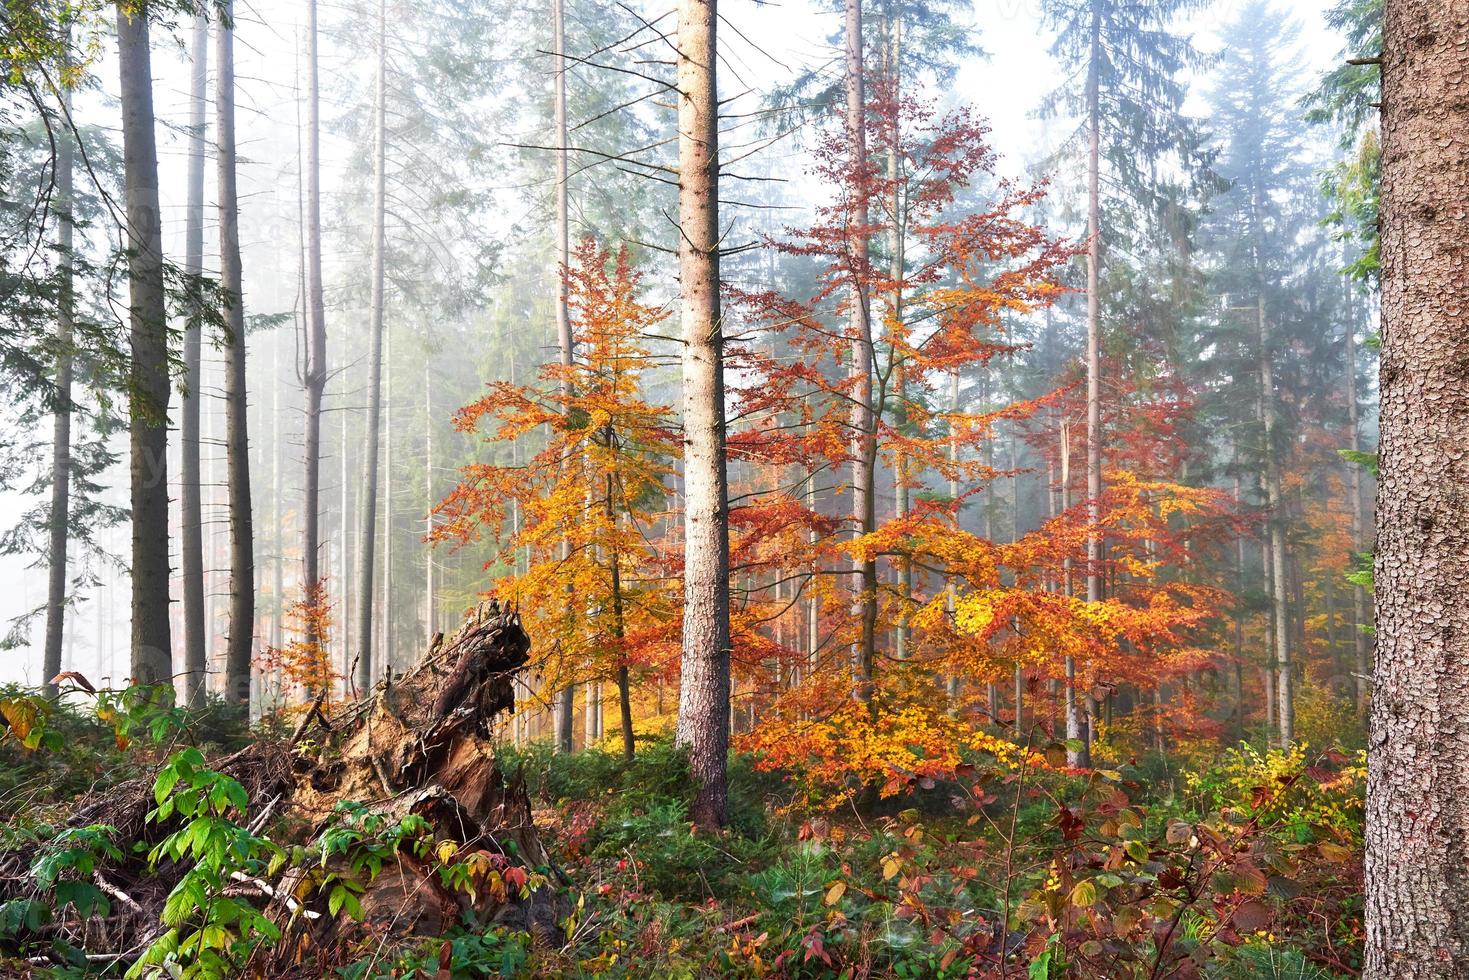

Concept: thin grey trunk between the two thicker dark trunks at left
[[179, 13, 209, 708]]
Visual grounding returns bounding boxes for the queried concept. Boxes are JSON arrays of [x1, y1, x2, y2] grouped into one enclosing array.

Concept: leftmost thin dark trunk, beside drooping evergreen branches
[[41, 82, 76, 698]]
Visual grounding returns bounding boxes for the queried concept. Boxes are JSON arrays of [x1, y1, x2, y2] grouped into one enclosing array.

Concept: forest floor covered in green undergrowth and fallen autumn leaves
[[0, 692, 1363, 980]]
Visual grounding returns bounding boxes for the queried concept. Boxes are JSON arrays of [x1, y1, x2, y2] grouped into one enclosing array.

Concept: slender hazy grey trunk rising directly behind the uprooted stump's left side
[[355, 0, 388, 692]]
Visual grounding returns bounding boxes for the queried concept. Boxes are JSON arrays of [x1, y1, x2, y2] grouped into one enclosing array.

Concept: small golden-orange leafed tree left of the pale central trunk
[[433, 239, 680, 754]]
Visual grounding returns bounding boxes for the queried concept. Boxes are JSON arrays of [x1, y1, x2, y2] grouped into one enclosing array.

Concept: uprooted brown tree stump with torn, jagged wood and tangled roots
[[0, 601, 569, 977]]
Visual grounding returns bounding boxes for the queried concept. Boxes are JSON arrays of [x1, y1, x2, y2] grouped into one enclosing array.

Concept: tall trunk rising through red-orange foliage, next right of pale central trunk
[[843, 0, 877, 701]]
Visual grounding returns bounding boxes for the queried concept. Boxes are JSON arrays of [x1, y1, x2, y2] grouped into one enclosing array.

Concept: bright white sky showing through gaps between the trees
[[0, 0, 1341, 683]]
